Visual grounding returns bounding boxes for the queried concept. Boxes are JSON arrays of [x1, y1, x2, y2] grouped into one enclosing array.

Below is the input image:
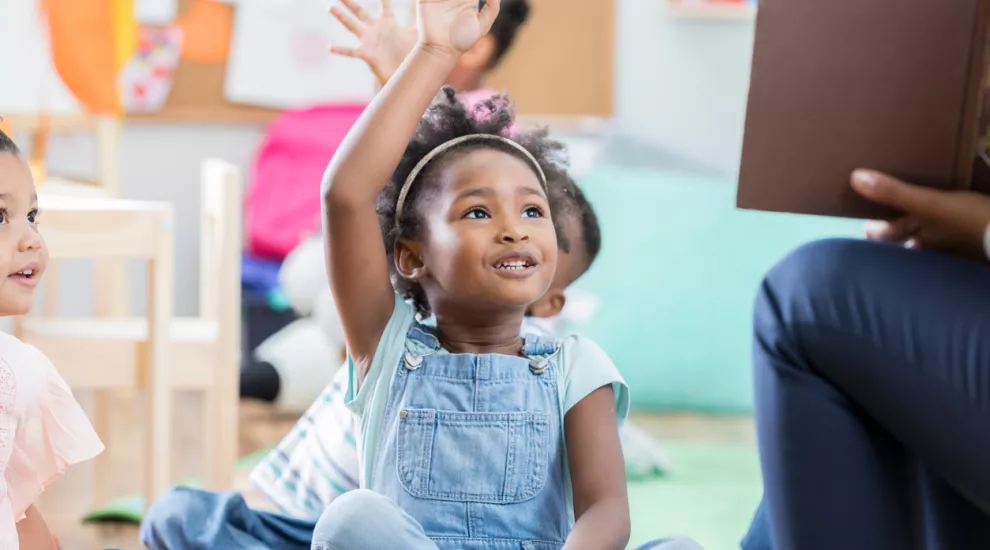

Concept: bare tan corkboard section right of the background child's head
[[486, 0, 616, 117]]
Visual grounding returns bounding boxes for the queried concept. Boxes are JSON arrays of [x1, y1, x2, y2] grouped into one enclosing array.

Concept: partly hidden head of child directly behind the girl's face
[[527, 174, 602, 317]]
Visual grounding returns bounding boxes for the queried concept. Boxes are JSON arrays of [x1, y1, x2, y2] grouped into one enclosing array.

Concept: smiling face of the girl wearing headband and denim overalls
[[396, 148, 557, 314]]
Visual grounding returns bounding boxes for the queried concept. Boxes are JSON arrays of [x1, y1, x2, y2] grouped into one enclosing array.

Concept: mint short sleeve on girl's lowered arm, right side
[[558, 336, 629, 423]]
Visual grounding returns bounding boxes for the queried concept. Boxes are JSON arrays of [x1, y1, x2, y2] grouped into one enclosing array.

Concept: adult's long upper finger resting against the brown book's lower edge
[[852, 170, 953, 219]]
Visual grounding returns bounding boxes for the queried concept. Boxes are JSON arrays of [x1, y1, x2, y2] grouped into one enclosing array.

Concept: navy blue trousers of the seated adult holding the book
[[746, 240, 990, 550]]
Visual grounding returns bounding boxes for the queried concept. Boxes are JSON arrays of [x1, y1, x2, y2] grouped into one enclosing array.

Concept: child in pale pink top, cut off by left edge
[[0, 131, 103, 550]]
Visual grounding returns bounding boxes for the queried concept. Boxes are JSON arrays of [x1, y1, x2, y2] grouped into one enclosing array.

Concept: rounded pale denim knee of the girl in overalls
[[313, 489, 403, 550]]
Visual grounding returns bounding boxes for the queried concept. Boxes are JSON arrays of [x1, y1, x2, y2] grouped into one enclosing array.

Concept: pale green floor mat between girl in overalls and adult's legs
[[629, 442, 762, 550]]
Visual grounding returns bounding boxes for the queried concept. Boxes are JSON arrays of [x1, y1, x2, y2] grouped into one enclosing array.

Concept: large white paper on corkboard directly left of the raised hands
[[224, 0, 408, 109]]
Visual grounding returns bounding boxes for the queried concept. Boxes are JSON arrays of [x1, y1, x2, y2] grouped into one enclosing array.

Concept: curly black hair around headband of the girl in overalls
[[377, 87, 567, 318]]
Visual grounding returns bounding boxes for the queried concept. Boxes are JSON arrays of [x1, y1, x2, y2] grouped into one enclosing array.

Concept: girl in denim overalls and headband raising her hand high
[[313, 0, 697, 550]]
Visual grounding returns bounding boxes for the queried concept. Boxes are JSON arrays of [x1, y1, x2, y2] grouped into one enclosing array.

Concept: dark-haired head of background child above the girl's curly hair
[[448, 0, 529, 91]]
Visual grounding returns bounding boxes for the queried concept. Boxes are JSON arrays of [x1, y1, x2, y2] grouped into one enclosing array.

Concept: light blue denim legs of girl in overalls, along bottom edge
[[313, 489, 702, 550]]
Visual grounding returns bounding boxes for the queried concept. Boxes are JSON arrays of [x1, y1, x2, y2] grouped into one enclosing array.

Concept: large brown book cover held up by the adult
[[736, 0, 990, 218]]
